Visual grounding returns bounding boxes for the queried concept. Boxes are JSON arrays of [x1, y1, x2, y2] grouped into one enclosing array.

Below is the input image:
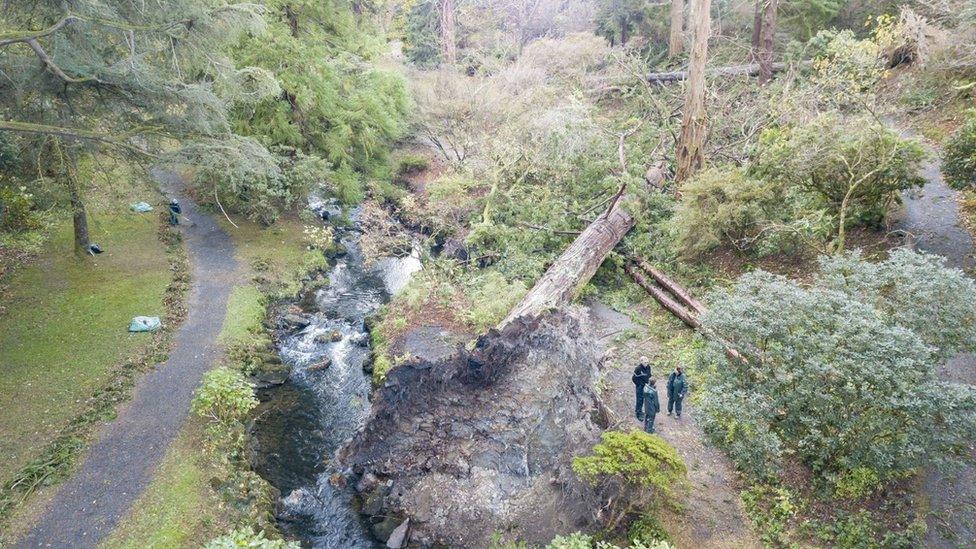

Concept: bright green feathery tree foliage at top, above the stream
[[234, 0, 408, 170]]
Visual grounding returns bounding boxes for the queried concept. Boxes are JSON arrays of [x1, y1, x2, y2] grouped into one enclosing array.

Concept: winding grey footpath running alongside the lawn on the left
[[17, 169, 239, 548]]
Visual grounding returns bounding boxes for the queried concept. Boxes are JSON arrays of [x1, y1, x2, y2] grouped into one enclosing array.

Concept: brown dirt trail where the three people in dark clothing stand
[[590, 303, 761, 548]]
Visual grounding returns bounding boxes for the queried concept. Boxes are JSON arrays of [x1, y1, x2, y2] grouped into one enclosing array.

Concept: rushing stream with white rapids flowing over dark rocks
[[255, 198, 420, 548]]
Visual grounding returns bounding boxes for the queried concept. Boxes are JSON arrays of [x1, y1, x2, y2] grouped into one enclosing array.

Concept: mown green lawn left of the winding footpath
[[0, 213, 171, 480]]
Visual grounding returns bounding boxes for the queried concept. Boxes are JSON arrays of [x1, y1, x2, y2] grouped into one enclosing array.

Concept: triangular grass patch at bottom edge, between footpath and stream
[[101, 419, 228, 549]]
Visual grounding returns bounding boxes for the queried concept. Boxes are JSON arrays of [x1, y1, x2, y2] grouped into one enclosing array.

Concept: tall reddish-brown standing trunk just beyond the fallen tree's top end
[[675, 0, 712, 182]]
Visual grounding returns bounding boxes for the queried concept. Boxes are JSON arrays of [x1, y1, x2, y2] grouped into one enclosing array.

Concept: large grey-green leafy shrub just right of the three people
[[700, 250, 976, 490]]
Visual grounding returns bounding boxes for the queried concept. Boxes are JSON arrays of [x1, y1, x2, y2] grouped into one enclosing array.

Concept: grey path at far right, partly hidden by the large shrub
[[893, 130, 976, 547]]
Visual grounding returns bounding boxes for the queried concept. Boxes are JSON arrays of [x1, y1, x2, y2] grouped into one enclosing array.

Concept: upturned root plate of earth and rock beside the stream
[[340, 311, 606, 547]]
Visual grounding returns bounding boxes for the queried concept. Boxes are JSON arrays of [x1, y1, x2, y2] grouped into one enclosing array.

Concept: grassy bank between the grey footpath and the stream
[[103, 213, 325, 547]]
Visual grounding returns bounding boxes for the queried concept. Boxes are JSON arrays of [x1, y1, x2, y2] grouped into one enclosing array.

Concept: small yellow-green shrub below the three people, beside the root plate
[[573, 431, 687, 496]]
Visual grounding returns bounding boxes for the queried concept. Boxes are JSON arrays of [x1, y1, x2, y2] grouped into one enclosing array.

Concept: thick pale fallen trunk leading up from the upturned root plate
[[498, 166, 667, 329]]
